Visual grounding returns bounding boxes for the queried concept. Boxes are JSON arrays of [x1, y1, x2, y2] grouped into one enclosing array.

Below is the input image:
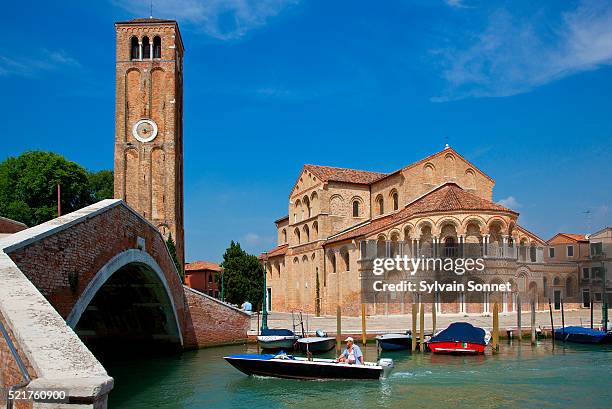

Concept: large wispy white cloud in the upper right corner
[[432, 0, 612, 102]]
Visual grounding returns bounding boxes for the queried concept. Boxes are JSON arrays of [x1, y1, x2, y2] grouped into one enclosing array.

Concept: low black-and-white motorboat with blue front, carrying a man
[[224, 353, 393, 380]]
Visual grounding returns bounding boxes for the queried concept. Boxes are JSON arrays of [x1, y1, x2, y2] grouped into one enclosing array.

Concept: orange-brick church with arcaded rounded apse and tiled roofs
[[263, 146, 580, 315]]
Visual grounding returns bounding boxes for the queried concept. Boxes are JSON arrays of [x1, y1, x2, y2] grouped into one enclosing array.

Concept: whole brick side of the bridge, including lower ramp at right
[[8, 199, 248, 348]]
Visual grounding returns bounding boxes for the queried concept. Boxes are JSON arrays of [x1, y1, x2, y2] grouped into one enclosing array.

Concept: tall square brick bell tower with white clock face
[[115, 18, 185, 265]]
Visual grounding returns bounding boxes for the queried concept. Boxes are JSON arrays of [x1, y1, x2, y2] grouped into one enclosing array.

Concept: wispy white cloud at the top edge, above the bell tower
[[111, 0, 299, 40]]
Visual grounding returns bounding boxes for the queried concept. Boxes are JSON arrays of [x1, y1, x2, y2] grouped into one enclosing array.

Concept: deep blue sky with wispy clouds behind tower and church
[[0, 0, 612, 261]]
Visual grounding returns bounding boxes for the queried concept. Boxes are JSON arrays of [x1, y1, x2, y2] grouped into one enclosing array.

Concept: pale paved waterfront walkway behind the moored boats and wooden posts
[[249, 306, 609, 338]]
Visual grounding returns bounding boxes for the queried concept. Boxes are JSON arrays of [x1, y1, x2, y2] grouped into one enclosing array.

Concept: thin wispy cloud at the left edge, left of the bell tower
[[0, 49, 80, 76]]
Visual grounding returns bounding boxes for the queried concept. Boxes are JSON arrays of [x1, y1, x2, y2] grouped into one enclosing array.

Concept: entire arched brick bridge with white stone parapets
[[0, 200, 249, 408]]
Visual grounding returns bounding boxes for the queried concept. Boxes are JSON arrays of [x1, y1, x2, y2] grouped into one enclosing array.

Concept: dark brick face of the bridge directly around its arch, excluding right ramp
[[9, 206, 183, 318]]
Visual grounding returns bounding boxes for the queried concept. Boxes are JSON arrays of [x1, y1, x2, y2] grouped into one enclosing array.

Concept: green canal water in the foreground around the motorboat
[[103, 341, 612, 409]]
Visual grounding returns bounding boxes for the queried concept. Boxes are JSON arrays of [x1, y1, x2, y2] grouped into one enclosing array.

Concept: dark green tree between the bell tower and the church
[[221, 241, 263, 310]]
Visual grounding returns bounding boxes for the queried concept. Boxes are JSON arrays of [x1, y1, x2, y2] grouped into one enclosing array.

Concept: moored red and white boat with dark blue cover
[[427, 322, 491, 355]]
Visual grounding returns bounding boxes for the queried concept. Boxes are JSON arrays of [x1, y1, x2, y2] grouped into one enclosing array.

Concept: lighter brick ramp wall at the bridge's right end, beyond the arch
[[183, 287, 250, 348]]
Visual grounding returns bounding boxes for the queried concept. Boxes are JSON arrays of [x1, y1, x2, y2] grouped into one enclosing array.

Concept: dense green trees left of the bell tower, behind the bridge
[[0, 151, 112, 226]]
